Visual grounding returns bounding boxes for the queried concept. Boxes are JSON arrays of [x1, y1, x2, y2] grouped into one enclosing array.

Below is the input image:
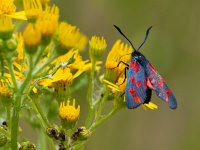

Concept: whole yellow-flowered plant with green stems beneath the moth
[[0, 0, 157, 150]]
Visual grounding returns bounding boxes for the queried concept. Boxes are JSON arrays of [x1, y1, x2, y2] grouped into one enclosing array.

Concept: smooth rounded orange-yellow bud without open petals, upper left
[[23, 23, 41, 50]]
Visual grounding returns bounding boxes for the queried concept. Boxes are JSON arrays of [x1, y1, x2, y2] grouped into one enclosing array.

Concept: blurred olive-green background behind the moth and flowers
[[52, 0, 200, 150]]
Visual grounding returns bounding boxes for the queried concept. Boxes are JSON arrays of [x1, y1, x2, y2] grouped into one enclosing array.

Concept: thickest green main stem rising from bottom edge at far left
[[11, 56, 33, 150]]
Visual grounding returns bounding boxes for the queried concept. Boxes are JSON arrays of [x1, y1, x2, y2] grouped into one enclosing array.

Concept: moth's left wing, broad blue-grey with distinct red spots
[[125, 61, 147, 109]]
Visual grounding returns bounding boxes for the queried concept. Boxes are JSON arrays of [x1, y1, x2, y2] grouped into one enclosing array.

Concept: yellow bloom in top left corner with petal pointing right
[[0, 0, 26, 20]]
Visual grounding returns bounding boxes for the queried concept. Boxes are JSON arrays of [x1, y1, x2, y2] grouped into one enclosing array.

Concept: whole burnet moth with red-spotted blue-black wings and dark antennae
[[114, 25, 177, 109]]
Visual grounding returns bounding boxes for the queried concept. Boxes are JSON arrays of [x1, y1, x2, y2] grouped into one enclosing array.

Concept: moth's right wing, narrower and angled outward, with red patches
[[145, 63, 177, 109]]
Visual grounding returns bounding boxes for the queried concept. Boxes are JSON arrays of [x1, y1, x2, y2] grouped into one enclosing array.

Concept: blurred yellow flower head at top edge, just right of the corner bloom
[[23, 0, 42, 22]]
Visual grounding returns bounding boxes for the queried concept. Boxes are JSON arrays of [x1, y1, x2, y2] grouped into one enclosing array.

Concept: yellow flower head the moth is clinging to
[[104, 40, 132, 83]]
